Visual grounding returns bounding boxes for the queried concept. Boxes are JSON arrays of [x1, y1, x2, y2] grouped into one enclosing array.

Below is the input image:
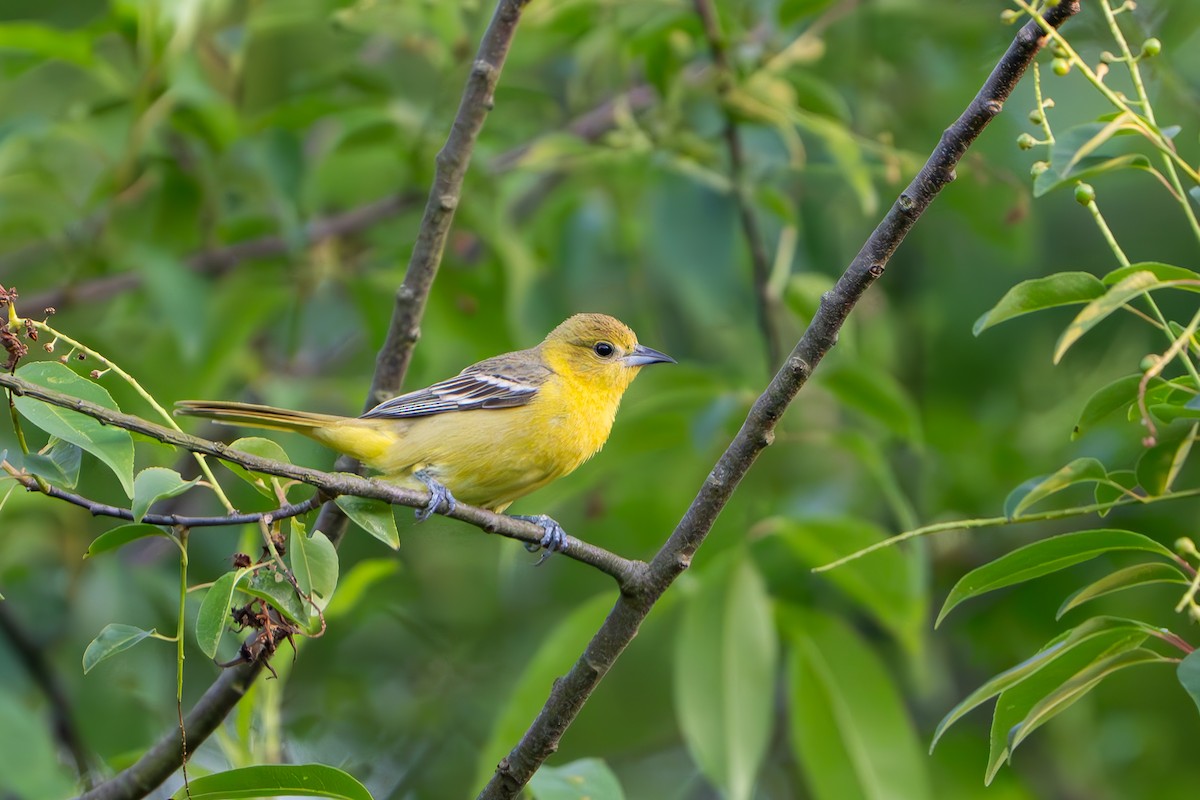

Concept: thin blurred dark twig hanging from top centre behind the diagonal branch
[[694, 0, 780, 369]]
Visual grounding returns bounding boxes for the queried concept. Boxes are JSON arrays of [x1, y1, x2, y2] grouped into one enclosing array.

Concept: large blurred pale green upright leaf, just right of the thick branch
[[674, 553, 778, 800]]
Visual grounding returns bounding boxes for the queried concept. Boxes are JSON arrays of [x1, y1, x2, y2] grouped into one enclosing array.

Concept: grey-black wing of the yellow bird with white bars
[[362, 350, 553, 420]]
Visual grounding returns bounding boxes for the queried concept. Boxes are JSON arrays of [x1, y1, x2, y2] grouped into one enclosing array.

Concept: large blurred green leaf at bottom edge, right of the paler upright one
[[780, 607, 932, 800]]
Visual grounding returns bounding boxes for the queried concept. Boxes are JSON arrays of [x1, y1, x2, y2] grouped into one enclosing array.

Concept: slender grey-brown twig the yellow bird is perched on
[[0, 373, 646, 587]]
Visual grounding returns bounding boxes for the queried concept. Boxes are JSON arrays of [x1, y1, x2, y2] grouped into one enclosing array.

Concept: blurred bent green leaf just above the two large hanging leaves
[[770, 517, 929, 654]]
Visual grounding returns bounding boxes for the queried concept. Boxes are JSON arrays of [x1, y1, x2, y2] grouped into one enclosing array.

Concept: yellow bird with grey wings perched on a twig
[[176, 314, 674, 552]]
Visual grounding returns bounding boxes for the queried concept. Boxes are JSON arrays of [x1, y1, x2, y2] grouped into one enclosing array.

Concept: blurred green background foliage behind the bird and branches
[[0, 0, 1200, 800]]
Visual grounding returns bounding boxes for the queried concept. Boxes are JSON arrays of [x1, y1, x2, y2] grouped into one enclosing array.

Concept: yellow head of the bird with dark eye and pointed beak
[[541, 314, 674, 395]]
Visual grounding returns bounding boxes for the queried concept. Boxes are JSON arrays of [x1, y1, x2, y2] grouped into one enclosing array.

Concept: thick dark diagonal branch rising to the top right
[[479, 0, 1079, 800]]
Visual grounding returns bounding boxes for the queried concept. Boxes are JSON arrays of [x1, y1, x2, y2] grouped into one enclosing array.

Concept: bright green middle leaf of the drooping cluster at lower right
[[984, 618, 1150, 784]]
